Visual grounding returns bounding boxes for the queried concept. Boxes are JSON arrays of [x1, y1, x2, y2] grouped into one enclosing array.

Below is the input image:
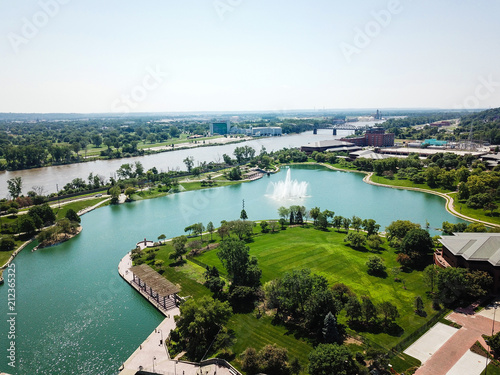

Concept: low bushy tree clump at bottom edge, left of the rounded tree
[[241, 344, 301, 375]]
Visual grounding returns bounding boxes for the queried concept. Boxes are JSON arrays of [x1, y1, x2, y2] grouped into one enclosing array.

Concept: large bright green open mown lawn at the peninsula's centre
[[196, 227, 433, 349]]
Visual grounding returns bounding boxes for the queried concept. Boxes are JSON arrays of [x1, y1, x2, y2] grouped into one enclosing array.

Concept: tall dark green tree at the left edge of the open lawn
[[217, 237, 262, 287]]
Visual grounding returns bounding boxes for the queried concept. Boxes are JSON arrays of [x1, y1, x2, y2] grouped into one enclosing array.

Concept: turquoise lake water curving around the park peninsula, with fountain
[[0, 166, 460, 375]]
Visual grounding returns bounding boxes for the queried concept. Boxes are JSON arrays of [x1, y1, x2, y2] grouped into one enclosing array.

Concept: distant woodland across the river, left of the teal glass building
[[0, 116, 209, 170]]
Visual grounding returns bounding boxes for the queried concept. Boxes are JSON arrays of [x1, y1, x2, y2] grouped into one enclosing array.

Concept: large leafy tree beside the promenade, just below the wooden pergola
[[174, 297, 232, 360]]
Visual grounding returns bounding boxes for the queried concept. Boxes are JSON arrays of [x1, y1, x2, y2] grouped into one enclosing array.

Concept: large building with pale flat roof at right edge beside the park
[[436, 233, 500, 293]]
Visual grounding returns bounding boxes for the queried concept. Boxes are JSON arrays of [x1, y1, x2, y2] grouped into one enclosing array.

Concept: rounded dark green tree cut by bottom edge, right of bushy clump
[[308, 344, 357, 375]]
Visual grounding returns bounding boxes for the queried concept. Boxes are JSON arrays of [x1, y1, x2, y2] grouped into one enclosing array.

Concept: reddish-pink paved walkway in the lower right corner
[[415, 312, 500, 375]]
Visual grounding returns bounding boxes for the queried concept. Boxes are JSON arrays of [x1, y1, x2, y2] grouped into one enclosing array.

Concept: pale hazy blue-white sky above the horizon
[[0, 0, 500, 113]]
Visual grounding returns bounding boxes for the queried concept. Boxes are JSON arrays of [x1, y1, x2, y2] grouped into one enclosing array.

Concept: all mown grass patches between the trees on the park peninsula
[[137, 227, 435, 367]]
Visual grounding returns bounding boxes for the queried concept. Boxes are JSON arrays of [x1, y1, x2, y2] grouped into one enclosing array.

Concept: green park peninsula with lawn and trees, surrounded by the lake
[[132, 206, 491, 373]]
